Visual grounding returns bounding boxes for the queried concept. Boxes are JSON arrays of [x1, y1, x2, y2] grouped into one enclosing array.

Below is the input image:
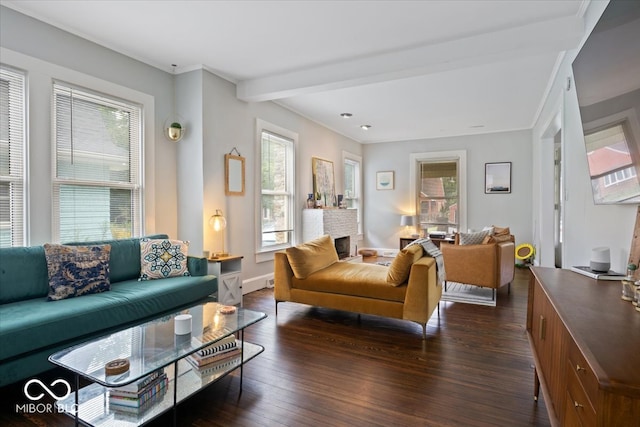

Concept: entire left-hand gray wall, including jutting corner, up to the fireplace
[[0, 7, 362, 290]]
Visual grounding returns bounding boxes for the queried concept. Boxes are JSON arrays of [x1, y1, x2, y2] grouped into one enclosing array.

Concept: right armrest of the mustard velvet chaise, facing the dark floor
[[403, 256, 442, 324]]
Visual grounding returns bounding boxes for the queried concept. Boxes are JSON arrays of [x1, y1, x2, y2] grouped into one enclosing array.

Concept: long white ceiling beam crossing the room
[[236, 16, 584, 102]]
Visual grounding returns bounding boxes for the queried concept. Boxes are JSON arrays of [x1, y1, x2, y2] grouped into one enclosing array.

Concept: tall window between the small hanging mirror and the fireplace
[[258, 128, 295, 251]]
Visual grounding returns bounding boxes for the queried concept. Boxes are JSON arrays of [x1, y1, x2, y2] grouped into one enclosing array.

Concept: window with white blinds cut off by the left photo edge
[[0, 66, 26, 248]]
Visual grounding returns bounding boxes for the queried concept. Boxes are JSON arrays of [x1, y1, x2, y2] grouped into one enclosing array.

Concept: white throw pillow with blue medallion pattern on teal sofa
[[138, 237, 190, 280]]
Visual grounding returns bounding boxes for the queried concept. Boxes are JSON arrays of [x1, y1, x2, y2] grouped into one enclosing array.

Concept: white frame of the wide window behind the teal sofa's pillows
[[51, 79, 145, 242]]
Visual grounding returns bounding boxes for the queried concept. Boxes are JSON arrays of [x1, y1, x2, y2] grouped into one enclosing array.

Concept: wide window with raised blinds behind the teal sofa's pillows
[[53, 83, 142, 242]]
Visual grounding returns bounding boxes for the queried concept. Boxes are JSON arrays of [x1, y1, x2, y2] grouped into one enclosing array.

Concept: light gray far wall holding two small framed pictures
[[363, 131, 532, 249]]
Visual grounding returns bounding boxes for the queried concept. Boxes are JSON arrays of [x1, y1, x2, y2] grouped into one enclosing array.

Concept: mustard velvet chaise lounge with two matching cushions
[[274, 235, 442, 339]]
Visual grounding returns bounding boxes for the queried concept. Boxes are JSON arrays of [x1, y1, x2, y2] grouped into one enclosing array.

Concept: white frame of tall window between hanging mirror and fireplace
[[255, 119, 299, 262]]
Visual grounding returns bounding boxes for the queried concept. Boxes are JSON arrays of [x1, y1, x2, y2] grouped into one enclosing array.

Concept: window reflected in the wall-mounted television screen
[[585, 121, 640, 203]]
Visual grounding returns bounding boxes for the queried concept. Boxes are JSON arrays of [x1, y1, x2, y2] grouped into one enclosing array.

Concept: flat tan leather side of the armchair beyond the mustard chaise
[[440, 243, 498, 288]]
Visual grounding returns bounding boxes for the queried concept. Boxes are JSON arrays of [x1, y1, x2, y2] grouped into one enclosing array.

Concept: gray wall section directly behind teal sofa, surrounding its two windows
[[0, 6, 178, 244]]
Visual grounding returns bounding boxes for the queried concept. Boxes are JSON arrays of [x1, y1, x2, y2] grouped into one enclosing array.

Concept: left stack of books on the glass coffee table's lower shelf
[[109, 369, 169, 410]]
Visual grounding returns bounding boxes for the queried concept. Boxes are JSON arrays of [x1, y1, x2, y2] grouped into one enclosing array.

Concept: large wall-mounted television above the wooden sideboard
[[573, 0, 640, 204]]
